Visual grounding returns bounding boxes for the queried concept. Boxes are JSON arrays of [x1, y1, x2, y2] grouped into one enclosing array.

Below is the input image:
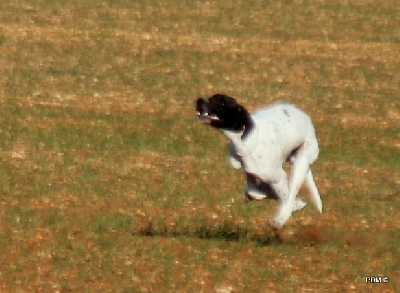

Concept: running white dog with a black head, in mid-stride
[[196, 94, 322, 228]]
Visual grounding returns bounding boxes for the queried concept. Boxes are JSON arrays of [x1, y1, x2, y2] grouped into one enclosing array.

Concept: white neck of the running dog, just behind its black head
[[222, 127, 258, 157]]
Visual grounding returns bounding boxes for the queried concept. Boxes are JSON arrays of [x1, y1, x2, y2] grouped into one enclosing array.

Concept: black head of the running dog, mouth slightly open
[[196, 94, 253, 138]]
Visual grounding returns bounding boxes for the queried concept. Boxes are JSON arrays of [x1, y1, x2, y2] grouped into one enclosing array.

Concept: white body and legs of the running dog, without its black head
[[222, 104, 322, 228]]
